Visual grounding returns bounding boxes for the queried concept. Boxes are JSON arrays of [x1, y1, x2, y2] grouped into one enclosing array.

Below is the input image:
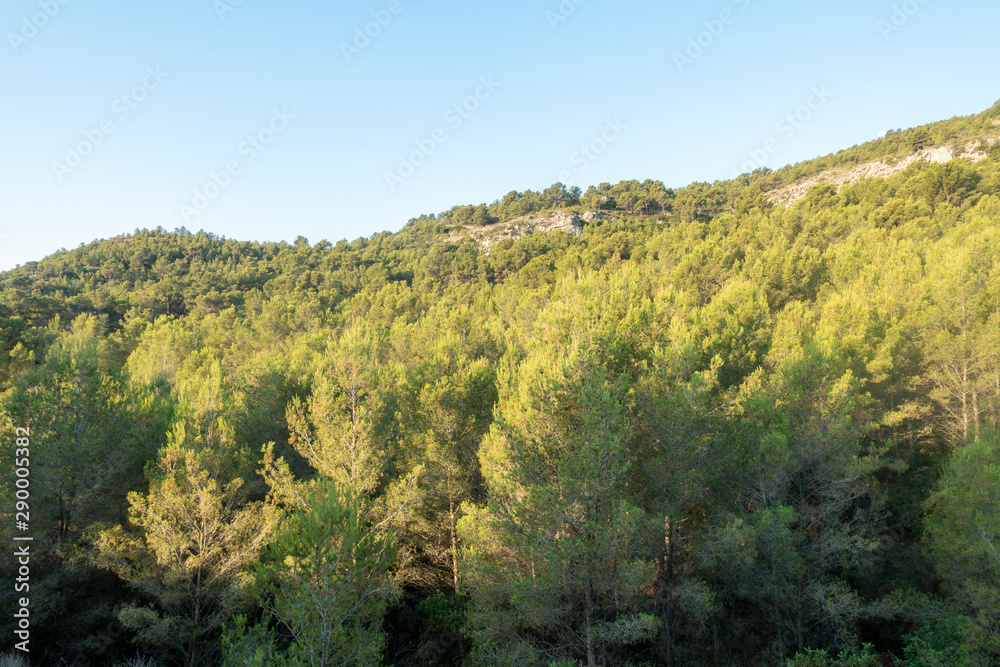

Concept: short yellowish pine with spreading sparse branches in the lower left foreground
[[97, 441, 277, 667]]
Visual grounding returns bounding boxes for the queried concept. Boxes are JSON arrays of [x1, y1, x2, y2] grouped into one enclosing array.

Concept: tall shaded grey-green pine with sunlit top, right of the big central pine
[[720, 344, 885, 658]]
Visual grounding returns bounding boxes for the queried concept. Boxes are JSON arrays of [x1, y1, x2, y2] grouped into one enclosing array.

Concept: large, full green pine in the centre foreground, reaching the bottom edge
[[459, 345, 657, 667]]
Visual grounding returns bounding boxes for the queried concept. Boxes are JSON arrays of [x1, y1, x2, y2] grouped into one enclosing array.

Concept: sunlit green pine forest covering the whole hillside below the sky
[[0, 102, 1000, 667]]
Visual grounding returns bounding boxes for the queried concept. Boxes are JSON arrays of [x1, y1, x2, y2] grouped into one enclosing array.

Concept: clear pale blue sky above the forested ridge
[[0, 0, 1000, 270]]
